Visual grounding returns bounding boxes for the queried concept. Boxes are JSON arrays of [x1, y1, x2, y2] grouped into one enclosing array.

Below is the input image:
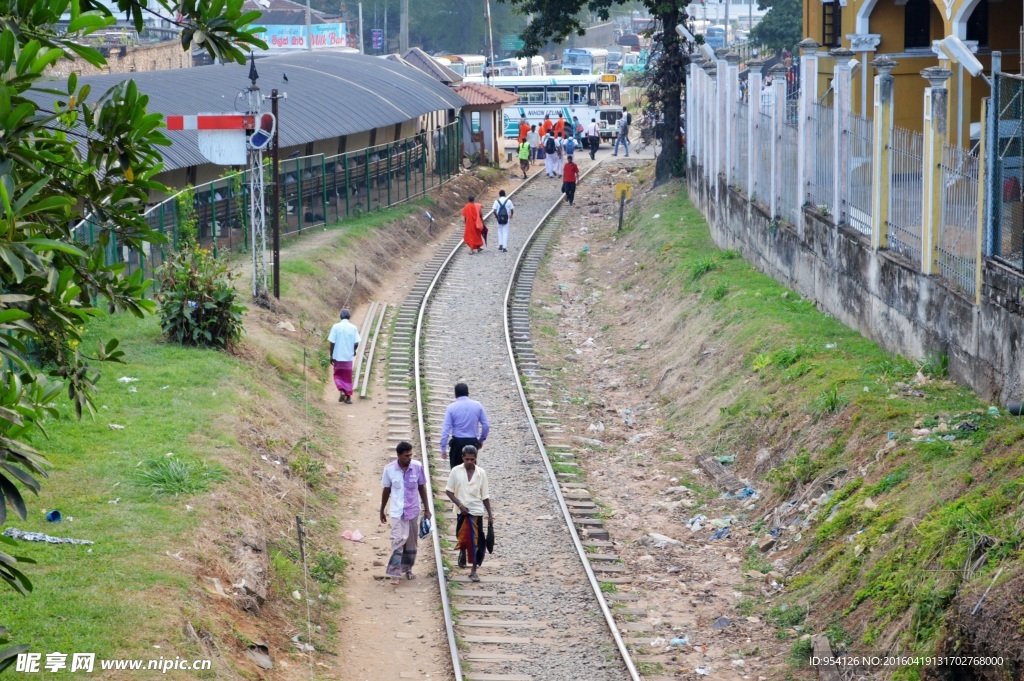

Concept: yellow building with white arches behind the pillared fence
[[804, 0, 1024, 146]]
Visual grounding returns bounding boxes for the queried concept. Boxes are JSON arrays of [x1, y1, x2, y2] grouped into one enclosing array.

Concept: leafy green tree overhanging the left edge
[[0, 0, 265, 670]]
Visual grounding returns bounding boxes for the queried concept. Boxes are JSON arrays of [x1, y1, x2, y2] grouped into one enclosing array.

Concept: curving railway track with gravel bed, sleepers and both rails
[[387, 159, 640, 681]]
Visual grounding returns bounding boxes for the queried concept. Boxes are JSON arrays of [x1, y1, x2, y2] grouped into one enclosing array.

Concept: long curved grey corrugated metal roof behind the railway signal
[[39, 50, 466, 170]]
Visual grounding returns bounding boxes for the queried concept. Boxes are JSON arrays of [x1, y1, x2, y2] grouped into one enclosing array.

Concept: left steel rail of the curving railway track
[[413, 164, 548, 681]]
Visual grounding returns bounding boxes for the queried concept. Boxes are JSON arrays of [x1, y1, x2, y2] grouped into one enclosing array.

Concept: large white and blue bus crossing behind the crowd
[[467, 74, 623, 139]]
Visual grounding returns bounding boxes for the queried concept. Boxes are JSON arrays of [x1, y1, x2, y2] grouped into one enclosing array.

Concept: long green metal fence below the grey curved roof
[[76, 120, 462, 278]]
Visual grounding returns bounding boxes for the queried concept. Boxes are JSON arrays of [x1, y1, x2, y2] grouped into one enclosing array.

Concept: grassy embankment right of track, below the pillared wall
[[598, 178, 1024, 678]]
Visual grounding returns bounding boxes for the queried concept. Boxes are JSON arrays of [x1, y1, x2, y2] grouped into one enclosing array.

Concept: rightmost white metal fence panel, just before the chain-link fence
[[936, 145, 978, 294]]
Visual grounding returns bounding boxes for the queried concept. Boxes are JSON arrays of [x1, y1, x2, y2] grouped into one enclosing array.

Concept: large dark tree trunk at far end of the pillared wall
[[654, 2, 686, 184]]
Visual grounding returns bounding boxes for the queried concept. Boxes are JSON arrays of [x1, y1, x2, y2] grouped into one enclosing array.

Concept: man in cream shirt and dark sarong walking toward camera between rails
[[444, 444, 495, 582]]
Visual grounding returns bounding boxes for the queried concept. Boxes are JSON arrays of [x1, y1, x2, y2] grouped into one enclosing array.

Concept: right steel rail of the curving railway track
[[502, 159, 640, 681]]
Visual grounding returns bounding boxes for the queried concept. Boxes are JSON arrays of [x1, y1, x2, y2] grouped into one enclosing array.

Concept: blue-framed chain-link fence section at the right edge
[[986, 73, 1024, 270]]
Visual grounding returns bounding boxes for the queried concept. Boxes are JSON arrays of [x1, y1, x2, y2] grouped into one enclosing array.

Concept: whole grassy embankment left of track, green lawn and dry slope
[[0, 200, 433, 677]]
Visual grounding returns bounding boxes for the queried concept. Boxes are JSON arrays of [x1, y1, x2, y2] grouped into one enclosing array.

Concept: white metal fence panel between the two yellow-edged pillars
[[886, 127, 924, 263]]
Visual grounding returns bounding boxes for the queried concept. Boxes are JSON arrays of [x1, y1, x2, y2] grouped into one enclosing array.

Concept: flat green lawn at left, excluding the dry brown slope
[[0, 316, 241, 656]]
